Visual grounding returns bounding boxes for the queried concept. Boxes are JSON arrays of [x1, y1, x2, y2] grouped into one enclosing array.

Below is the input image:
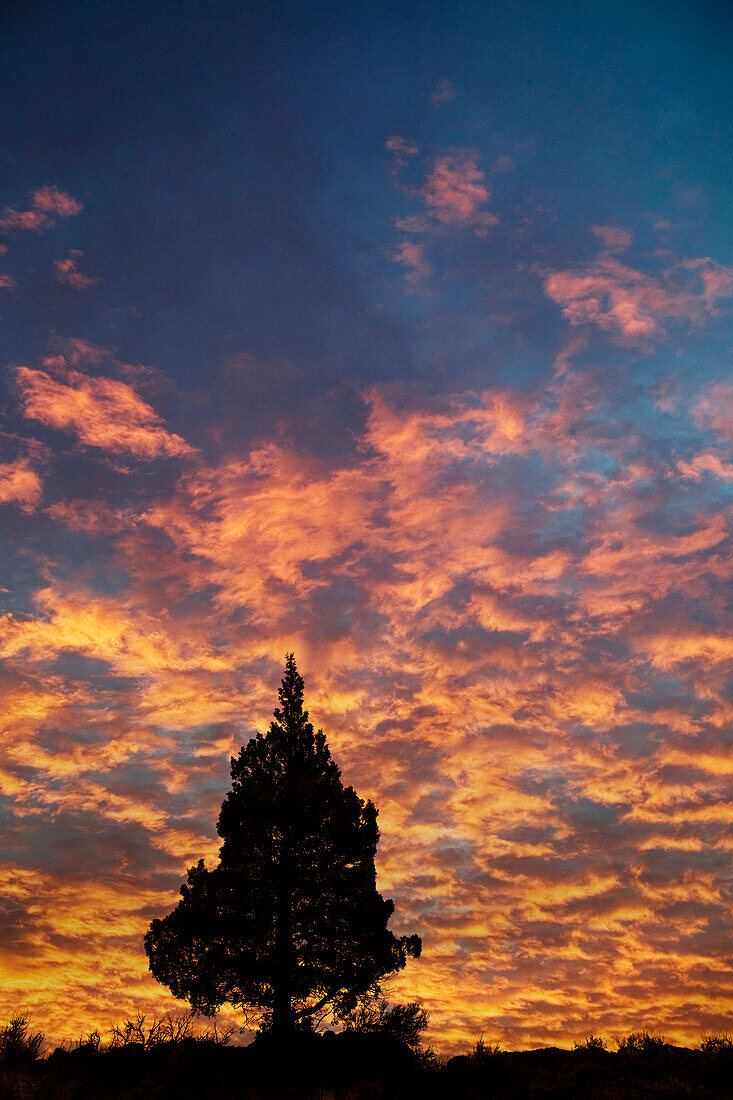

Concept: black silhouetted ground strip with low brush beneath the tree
[[0, 1036, 733, 1100]]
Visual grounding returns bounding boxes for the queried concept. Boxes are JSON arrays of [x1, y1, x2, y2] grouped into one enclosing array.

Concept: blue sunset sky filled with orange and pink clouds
[[0, 0, 733, 1053]]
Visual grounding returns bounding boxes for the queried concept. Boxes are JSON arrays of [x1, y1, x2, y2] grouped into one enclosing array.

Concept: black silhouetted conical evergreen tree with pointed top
[[145, 653, 422, 1034]]
